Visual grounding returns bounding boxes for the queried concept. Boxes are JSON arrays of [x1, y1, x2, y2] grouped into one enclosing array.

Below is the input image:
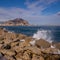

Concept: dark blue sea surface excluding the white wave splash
[[0, 26, 60, 42]]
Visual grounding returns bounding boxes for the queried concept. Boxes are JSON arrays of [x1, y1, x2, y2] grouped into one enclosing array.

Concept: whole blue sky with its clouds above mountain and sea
[[0, 0, 60, 25]]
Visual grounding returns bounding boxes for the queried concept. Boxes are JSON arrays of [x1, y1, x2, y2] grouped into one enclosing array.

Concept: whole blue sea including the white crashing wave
[[0, 26, 60, 42]]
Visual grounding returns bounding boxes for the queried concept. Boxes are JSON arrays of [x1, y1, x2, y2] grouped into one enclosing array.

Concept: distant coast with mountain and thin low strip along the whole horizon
[[0, 18, 60, 26]]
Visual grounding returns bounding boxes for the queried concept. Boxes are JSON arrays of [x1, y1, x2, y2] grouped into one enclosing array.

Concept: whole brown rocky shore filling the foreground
[[0, 28, 60, 60]]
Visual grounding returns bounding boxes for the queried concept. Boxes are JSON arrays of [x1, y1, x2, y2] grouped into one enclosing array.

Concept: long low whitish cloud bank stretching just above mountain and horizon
[[0, 7, 60, 25]]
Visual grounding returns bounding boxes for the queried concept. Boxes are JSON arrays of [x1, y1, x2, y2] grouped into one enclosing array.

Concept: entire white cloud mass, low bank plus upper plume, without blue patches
[[0, 0, 60, 25]]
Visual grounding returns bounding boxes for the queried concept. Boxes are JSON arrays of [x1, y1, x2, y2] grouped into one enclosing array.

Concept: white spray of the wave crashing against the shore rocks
[[33, 30, 53, 43]]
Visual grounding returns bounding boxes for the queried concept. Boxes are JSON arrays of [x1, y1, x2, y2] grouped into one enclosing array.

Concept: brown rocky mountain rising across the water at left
[[0, 18, 30, 26]]
